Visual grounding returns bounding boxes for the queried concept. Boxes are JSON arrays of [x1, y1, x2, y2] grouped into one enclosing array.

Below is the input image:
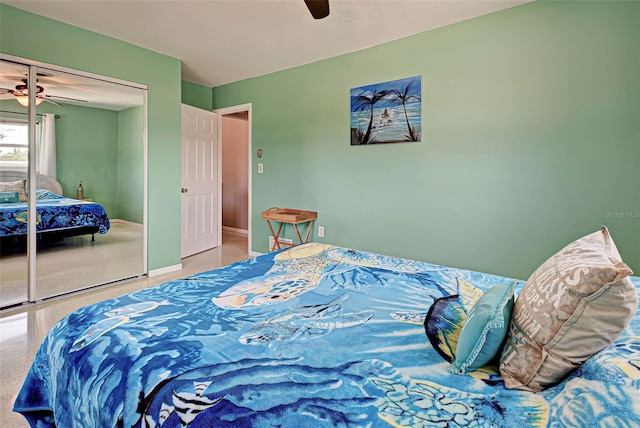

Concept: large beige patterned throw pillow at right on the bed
[[500, 226, 638, 391]]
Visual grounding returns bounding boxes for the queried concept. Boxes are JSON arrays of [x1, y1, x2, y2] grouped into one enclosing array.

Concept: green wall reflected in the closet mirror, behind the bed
[[57, 104, 144, 223]]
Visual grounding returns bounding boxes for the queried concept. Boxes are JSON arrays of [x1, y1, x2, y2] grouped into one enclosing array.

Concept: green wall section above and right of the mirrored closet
[[0, 4, 181, 270]]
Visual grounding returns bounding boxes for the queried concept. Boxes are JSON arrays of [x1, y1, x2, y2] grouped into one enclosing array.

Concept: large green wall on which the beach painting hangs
[[213, 2, 640, 278]]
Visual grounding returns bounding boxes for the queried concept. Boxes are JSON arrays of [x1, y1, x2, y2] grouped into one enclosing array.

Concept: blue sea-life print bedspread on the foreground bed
[[14, 243, 640, 428]]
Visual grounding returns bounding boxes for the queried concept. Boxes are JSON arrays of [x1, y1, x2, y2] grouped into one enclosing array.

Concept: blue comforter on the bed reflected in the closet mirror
[[0, 189, 111, 237]]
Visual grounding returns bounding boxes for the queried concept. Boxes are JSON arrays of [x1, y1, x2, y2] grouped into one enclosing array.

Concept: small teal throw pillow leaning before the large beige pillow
[[449, 281, 518, 374]]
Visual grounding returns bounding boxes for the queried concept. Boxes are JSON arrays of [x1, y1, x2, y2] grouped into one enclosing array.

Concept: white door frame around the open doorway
[[213, 103, 253, 254]]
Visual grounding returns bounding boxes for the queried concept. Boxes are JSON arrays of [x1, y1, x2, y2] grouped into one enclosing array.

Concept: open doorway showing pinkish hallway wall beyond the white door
[[216, 105, 251, 254]]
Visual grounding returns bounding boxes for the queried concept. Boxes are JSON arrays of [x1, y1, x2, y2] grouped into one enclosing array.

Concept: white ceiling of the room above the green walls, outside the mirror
[[2, 0, 531, 87]]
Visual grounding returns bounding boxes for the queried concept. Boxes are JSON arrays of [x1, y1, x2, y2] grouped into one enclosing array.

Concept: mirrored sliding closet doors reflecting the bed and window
[[0, 59, 146, 307]]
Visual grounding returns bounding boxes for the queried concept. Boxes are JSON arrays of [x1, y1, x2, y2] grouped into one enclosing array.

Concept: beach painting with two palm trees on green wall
[[351, 76, 422, 146]]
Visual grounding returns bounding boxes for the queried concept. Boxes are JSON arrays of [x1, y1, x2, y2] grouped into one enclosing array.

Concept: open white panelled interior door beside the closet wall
[[181, 104, 219, 257]]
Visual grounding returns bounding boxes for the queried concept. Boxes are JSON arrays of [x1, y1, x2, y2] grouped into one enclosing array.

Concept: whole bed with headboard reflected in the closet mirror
[[0, 171, 111, 249]]
